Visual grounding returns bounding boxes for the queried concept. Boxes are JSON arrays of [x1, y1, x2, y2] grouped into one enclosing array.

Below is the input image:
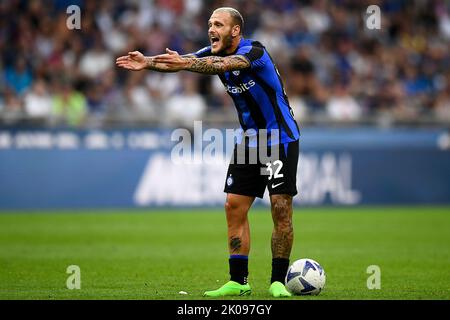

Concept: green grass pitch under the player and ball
[[0, 207, 450, 300]]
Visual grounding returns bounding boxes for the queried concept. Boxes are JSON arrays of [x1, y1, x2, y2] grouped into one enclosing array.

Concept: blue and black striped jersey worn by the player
[[195, 39, 300, 144]]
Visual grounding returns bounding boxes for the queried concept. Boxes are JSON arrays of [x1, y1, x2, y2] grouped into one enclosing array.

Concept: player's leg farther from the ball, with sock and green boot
[[204, 193, 255, 297]]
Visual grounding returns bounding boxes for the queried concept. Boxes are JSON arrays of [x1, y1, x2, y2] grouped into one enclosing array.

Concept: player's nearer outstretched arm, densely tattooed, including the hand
[[153, 49, 250, 74]]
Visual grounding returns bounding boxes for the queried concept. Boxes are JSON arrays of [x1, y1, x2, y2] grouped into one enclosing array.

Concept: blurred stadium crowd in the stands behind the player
[[0, 0, 450, 126]]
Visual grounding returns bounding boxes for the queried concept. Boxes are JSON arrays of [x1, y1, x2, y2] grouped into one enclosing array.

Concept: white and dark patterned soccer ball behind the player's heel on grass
[[285, 259, 325, 295]]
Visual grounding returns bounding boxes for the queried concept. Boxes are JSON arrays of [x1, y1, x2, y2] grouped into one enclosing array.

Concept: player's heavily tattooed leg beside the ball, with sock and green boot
[[269, 194, 294, 297]]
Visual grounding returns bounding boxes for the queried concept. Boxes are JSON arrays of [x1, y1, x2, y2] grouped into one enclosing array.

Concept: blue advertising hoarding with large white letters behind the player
[[0, 128, 450, 210]]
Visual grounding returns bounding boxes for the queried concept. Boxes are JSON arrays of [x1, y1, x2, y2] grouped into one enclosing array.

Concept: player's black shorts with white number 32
[[224, 140, 299, 198]]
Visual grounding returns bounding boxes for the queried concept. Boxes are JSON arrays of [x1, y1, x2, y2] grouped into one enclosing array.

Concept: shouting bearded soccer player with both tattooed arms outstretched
[[116, 7, 300, 297]]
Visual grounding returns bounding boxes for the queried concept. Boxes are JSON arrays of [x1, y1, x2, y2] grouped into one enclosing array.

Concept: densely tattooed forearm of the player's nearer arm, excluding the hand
[[186, 55, 250, 74]]
